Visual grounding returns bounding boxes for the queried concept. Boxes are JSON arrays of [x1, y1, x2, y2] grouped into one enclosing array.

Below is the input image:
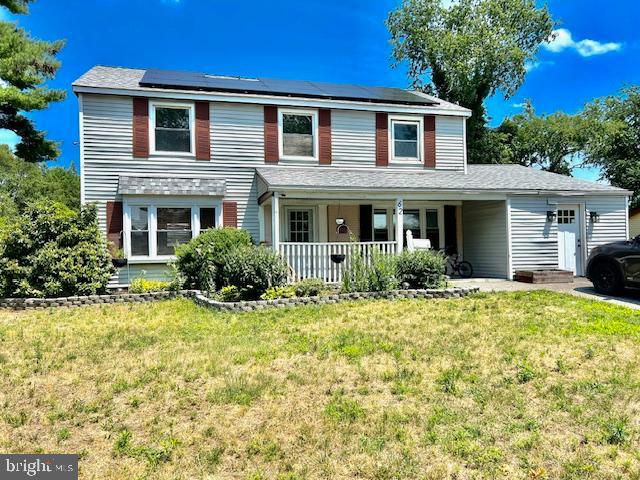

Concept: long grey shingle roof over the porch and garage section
[[257, 165, 629, 195]]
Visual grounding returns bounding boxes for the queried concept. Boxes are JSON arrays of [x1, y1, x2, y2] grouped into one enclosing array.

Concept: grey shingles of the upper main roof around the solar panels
[[73, 65, 469, 112]]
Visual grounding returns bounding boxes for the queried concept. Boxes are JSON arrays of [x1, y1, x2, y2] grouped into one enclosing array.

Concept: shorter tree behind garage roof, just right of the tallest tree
[[495, 102, 588, 175]]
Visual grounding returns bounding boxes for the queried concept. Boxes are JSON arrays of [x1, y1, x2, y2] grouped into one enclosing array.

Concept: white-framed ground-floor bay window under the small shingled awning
[[124, 201, 222, 260]]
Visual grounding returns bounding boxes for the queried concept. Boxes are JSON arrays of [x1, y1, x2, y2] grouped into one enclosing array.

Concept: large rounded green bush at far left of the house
[[0, 204, 113, 297]]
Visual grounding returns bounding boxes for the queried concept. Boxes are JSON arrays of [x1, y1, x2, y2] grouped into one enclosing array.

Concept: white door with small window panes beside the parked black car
[[558, 205, 582, 275]]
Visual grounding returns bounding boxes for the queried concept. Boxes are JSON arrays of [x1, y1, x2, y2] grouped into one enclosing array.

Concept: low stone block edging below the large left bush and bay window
[[0, 290, 199, 310]]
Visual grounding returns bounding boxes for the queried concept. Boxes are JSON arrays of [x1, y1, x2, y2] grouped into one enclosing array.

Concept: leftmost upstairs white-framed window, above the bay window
[[150, 103, 195, 154]]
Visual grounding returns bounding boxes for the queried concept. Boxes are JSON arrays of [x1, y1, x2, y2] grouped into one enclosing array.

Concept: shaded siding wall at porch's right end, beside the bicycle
[[462, 200, 509, 278]]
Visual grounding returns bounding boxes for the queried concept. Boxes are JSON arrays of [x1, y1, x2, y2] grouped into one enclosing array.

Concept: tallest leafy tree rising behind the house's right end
[[387, 0, 554, 163]]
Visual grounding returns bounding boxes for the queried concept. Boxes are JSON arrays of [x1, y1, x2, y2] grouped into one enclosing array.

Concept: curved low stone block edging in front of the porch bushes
[[193, 287, 480, 312]]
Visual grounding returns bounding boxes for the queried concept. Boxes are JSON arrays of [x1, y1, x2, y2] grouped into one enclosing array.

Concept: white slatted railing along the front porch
[[280, 242, 397, 283]]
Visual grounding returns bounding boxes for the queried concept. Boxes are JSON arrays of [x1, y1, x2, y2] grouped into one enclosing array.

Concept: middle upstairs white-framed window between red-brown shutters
[[279, 110, 318, 159]]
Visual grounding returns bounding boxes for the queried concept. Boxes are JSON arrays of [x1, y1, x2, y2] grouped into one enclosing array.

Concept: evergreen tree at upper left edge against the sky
[[0, 0, 65, 162]]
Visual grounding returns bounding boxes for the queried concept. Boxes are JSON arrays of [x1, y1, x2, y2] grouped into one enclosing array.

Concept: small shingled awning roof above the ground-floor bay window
[[118, 176, 225, 197]]
